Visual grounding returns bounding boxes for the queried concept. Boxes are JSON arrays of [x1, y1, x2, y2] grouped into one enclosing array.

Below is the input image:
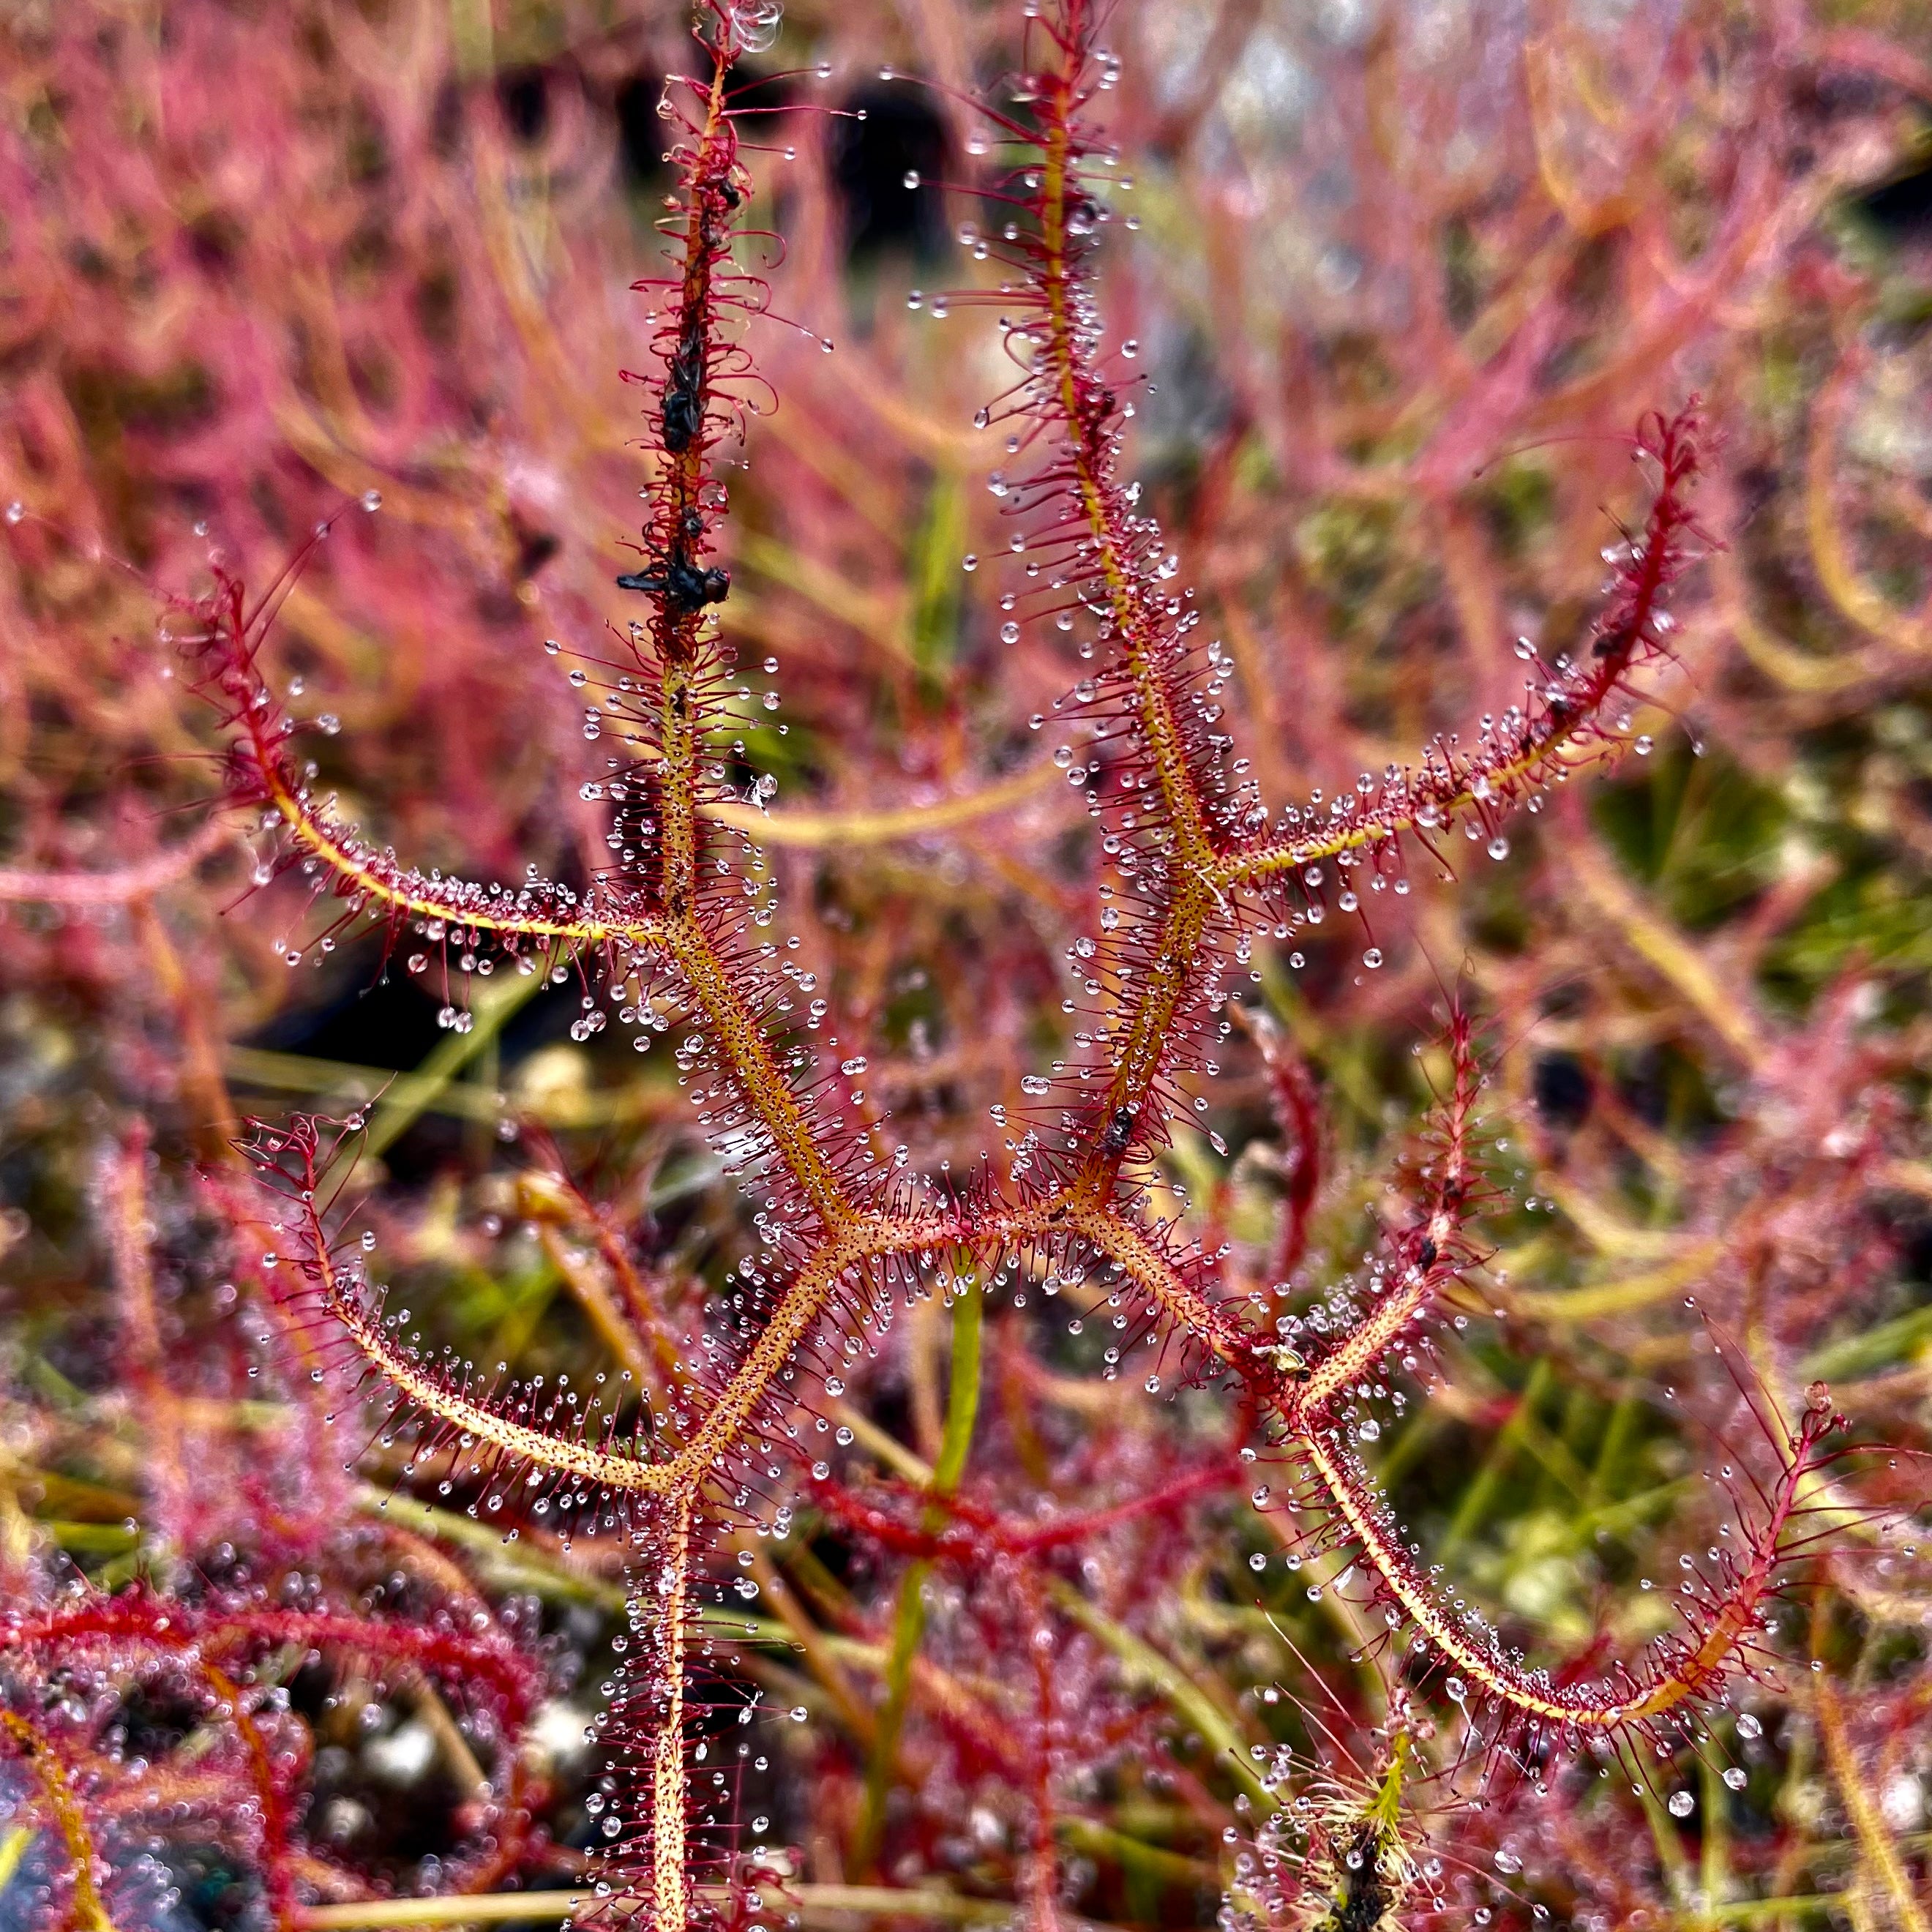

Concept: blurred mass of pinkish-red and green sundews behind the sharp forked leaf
[[6, 8, 1924, 1922]]
